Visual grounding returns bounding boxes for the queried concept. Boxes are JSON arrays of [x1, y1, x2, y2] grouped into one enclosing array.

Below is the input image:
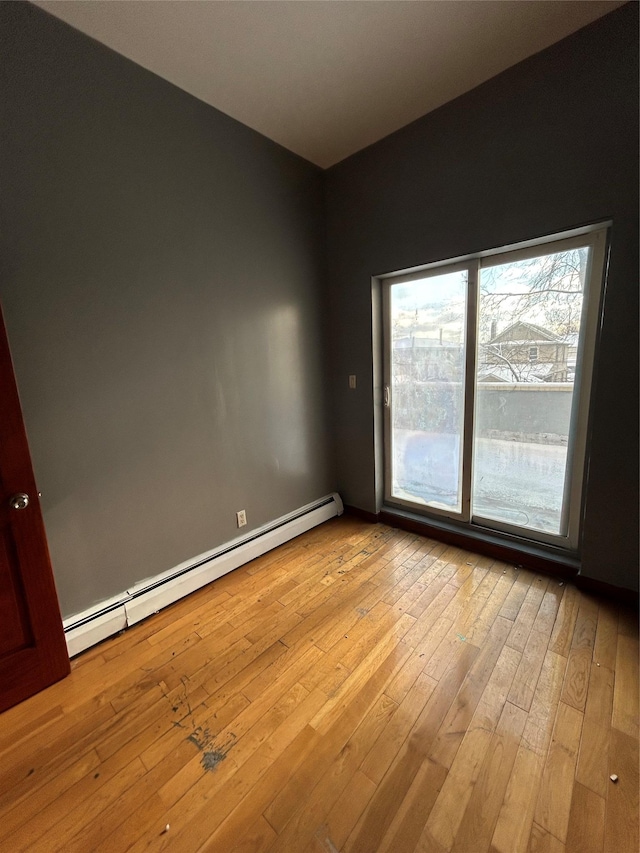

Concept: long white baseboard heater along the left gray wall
[[63, 492, 343, 657]]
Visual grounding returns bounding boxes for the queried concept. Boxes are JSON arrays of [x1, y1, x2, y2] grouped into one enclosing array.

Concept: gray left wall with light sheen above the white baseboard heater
[[0, 3, 335, 615]]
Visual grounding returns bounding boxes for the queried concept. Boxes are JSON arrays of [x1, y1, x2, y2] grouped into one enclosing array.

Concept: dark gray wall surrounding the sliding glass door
[[326, 3, 638, 588]]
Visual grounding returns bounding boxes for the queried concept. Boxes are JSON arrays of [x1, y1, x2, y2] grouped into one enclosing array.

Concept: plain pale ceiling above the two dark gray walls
[[36, 0, 622, 168]]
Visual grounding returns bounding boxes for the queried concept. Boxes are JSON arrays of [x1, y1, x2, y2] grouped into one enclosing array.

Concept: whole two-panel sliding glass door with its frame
[[383, 229, 606, 548]]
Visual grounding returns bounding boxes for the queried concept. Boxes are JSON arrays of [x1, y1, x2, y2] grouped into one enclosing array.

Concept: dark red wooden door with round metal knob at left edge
[[0, 302, 69, 711]]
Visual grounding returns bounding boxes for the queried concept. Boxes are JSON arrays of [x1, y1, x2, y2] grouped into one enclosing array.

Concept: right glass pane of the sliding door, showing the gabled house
[[472, 243, 589, 535]]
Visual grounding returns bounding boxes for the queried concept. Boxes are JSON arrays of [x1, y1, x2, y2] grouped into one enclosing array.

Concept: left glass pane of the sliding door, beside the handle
[[390, 270, 468, 512]]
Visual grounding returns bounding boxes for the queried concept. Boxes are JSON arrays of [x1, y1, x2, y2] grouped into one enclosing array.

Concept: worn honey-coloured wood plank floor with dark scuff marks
[[0, 518, 638, 853]]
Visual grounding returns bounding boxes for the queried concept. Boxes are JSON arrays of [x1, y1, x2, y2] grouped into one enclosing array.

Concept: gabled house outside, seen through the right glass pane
[[478, 320, 575, 382]]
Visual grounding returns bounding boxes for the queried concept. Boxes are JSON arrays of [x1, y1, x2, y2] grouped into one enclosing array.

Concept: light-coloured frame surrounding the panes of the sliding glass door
[[380, 222, 611, 554]]
